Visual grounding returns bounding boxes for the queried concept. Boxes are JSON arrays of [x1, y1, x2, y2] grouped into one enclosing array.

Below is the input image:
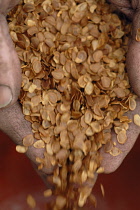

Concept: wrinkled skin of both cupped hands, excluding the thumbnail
[[0, 0, 140, 187]]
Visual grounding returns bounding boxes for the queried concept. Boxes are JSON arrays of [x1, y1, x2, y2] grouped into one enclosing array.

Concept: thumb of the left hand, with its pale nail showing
[[0, 14, 21, 108]]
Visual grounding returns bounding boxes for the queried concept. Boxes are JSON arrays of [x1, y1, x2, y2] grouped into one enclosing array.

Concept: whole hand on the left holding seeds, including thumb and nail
[[0, 0, 50, 185]]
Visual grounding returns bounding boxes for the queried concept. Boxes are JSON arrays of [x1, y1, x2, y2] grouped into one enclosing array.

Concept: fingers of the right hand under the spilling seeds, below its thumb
[[101, 99, 140, 173]]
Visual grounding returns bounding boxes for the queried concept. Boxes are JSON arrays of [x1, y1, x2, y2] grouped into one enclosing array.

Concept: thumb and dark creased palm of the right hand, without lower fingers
[[109, 0, 140, 96]]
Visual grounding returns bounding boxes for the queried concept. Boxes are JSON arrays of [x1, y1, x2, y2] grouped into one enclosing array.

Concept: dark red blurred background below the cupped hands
[[0, 132, 140, 210]]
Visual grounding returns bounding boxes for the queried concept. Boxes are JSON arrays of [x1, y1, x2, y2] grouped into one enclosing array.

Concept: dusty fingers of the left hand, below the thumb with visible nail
[[0, 102, 53, 174]]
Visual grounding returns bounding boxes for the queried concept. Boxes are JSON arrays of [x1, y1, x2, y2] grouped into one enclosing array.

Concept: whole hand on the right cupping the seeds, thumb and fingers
[[101, 0, 140, 173]]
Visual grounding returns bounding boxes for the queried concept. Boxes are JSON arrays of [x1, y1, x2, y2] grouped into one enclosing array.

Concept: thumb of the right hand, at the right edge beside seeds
[[126, 12, 140, 96]]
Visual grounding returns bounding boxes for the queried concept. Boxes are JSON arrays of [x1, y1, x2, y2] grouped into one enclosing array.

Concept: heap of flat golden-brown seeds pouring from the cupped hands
[[8, 0, 136, 210]]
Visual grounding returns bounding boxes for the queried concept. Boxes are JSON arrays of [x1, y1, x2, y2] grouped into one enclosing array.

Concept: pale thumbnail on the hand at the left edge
[[0, 85, 13, 108]]
